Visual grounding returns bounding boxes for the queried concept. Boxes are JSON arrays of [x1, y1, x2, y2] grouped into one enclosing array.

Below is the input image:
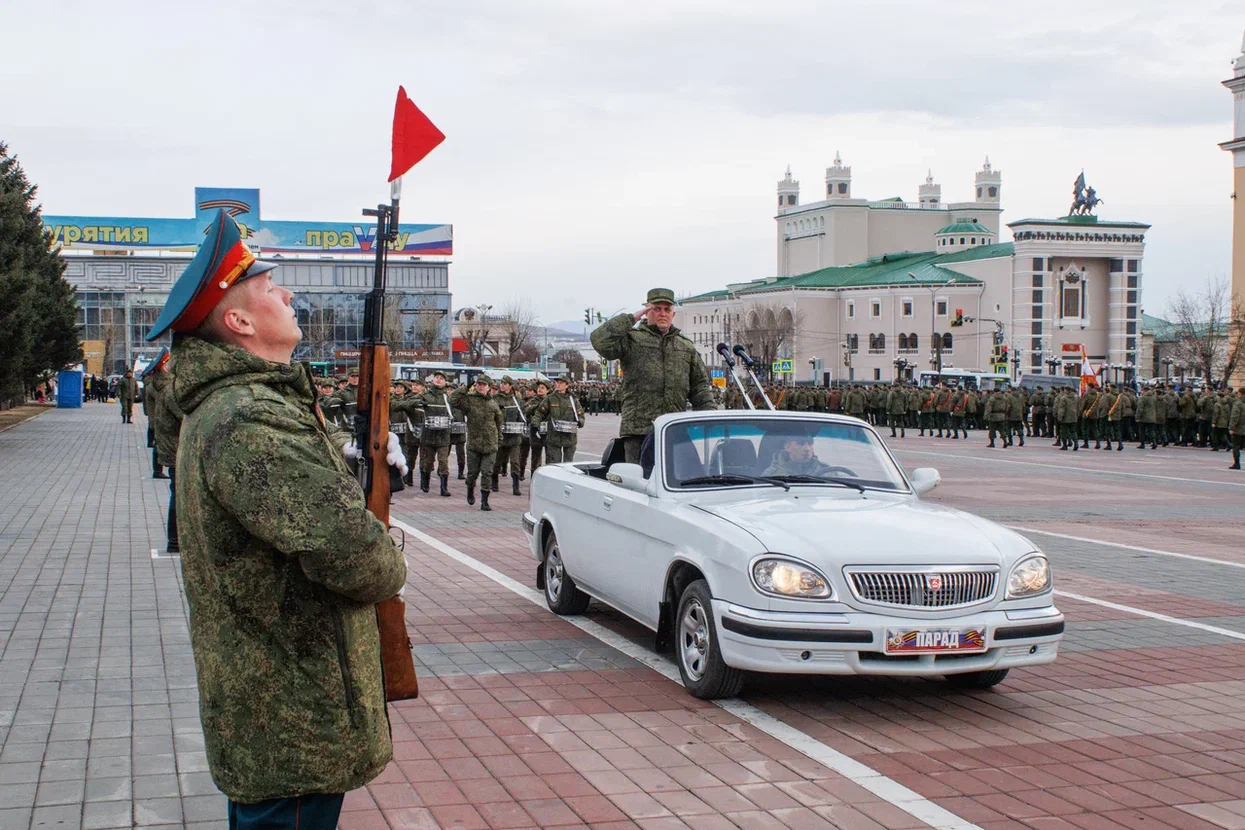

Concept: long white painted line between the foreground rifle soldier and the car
[[390, 518, 981, 830]]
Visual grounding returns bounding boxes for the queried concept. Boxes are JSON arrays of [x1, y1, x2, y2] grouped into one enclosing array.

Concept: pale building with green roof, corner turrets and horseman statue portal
[[676, 153, 1149, 382]]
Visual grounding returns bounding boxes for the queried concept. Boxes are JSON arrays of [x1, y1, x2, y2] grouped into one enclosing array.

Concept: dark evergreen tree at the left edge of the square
[[0, 142, 82, 401]]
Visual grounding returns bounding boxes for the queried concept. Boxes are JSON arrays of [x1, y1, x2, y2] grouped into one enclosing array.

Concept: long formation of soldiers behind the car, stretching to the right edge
[[718, 382, 1245, 469]]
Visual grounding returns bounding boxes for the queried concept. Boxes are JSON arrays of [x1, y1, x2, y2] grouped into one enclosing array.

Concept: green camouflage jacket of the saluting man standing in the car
[[591, 314, 716, 436]]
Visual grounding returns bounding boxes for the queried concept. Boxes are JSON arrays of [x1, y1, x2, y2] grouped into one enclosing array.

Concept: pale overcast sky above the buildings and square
[[0, 0, 1245, 322]]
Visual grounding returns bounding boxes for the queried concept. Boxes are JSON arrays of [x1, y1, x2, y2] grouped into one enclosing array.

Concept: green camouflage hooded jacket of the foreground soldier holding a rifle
[[167, 337, 406, 803]]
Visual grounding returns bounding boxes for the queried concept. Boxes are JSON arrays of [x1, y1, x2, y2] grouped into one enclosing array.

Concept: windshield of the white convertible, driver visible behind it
[[665, 416, 908, 490]]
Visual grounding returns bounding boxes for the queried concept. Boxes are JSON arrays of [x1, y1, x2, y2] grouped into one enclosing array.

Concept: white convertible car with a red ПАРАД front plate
[[523, 411, 1063, 698]]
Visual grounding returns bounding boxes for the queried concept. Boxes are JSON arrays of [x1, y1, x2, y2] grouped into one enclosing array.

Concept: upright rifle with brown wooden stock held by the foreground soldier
[[354, 179, 420, 701]]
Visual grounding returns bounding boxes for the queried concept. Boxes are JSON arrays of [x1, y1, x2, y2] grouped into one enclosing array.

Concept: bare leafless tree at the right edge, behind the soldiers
[[1168, 276, 1245, 383]]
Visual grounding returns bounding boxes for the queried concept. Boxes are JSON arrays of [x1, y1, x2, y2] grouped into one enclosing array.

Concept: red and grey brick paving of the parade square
[[7, 404, 1245, 830]]
